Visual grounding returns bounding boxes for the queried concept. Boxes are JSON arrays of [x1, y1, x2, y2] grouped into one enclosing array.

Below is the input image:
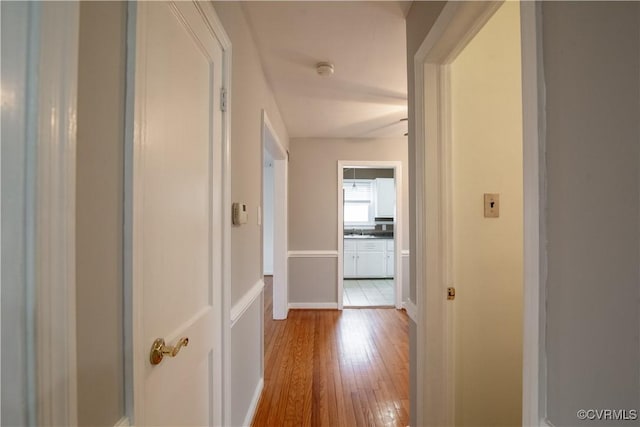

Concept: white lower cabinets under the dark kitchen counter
[[343, 239, 394, 279]]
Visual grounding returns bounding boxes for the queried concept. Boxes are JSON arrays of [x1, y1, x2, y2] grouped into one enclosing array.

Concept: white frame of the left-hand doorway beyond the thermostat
[[261, 109, 289, 320]]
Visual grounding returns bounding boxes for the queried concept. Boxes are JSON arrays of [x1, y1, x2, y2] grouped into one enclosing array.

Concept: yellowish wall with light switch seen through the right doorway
[[451, 2, 523, 426]]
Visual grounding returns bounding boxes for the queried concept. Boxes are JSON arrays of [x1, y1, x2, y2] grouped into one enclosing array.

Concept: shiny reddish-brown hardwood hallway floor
[[252, 276, 409, 427]]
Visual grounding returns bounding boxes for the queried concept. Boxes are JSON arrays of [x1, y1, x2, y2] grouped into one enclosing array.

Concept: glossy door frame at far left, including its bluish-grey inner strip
[[1, 2, 79, 425]]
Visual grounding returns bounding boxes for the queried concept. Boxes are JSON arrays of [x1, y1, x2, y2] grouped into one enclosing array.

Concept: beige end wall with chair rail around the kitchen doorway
[[289, 137, 410, 304]]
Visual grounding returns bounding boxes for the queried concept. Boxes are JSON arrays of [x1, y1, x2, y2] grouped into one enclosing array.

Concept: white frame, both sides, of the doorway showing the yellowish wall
[[413, 1, 546, 426]]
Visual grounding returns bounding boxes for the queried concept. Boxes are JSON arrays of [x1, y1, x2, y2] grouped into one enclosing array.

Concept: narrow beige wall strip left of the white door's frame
[[76, 2, 126, 426]]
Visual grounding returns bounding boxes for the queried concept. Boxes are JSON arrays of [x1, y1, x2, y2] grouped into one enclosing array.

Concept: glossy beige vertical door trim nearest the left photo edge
[[17, 2, 79, 426]]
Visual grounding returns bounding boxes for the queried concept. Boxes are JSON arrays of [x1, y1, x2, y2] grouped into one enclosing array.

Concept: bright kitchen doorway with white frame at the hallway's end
[[338, 162, 402, 309]]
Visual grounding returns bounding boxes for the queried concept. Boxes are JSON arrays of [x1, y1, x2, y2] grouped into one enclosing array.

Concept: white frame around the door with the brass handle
[[123, 2, 232, 425]]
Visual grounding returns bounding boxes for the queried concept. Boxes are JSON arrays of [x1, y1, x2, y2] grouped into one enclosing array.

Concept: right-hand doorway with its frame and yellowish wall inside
[[415, 2, 540, 425]]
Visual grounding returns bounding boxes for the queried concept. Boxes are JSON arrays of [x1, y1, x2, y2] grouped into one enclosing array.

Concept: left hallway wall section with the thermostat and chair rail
[[214, 1, 289, 425]]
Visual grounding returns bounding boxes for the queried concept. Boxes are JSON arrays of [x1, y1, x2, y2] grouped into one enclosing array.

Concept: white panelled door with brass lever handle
[[130, 2, 223, 426]]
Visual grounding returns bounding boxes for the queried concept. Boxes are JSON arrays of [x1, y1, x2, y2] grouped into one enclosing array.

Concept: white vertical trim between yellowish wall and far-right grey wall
[[520, 2, 550, 427]]
